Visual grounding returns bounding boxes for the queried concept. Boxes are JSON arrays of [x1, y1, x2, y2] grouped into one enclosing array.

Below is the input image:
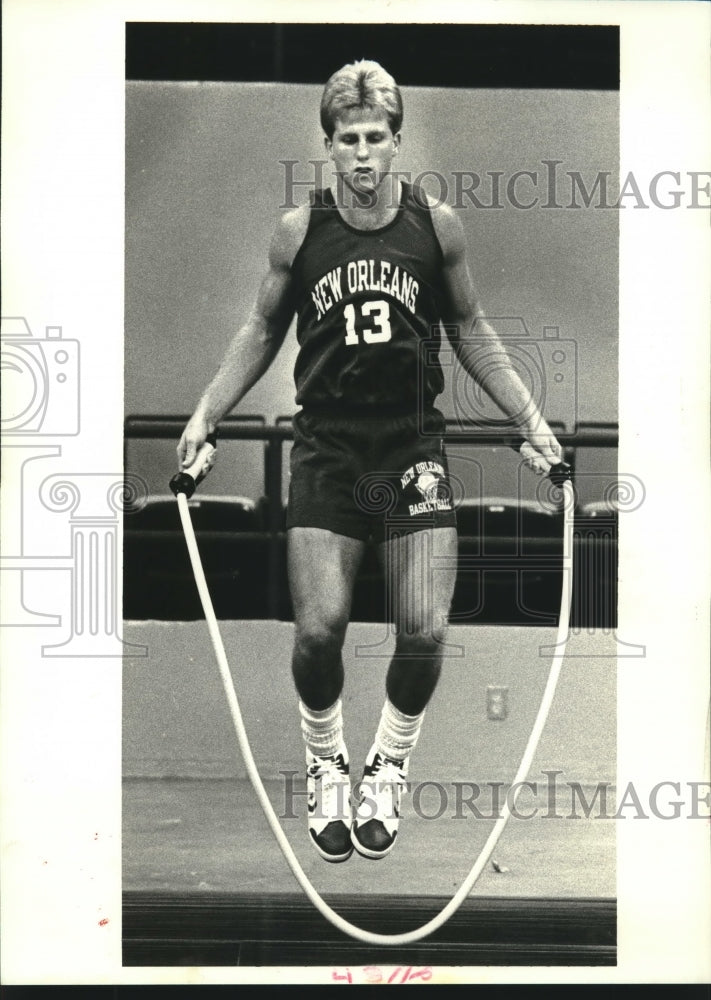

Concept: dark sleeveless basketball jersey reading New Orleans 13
[[292, 183, 444, 413]]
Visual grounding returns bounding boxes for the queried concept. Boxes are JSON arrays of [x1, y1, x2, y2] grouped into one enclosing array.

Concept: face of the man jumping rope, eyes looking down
[[326, 108, 400, 198]]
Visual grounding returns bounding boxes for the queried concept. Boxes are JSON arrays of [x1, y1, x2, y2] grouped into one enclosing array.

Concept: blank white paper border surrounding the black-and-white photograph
[[0, 0, 711, 985]]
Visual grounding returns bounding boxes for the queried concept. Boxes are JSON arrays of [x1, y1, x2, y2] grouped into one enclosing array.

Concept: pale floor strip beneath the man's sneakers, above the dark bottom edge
[[124, 778, 615, 898]]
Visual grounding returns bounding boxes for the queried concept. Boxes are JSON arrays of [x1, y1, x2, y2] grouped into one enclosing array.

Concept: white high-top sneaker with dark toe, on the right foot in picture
[[351, 746, 408, 860]]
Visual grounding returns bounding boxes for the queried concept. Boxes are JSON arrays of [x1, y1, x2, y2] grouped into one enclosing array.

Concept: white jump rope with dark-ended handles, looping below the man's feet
[[170, 435, 575, 945]]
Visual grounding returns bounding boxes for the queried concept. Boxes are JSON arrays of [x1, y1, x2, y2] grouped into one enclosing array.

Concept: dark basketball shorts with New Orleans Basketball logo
[[287, 410, 456, 542]]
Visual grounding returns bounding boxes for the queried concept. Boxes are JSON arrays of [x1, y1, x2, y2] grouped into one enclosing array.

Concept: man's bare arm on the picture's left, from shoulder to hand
[[177, 209, 308, 468]]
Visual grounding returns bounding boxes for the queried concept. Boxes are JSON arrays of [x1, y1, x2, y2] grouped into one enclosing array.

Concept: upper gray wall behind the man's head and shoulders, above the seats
[[125, 82, 618, 495]]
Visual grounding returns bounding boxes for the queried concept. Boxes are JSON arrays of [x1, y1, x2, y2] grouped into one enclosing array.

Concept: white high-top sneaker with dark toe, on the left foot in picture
[[306, 746, 353, 861]]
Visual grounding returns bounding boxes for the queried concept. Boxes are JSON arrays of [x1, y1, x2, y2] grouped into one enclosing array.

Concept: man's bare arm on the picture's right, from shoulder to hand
[[433, 205, 561, 472]]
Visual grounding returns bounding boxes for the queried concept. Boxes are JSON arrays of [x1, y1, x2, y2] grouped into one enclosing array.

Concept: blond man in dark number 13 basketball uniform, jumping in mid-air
[[178, 61, 561, 862]]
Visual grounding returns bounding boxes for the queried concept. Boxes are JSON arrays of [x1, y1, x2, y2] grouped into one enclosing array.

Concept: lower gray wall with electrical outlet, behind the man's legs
[[123, 622, 616, 784]]
